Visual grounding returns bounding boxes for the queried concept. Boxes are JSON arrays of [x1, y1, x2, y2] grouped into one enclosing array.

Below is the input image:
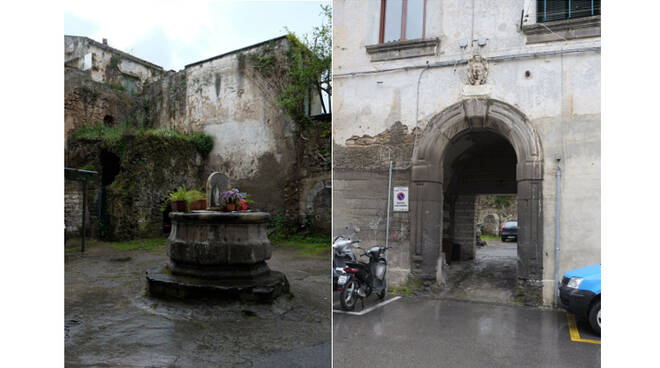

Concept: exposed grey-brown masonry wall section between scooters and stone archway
[[332, 122, 414, 286]]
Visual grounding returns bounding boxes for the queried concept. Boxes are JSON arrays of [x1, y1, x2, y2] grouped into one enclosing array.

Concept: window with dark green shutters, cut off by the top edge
[[536, 0, 600, 23]]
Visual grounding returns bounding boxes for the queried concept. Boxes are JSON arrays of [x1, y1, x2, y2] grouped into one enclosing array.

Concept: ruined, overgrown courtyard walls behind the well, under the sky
[[64, 36, 330, 239]]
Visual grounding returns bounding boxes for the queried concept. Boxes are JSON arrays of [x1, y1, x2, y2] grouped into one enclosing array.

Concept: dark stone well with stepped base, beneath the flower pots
[[147, 211, 289, 302]]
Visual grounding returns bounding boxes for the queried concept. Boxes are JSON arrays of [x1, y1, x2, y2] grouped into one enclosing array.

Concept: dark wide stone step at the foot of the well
[[147, 265, 289, 303]]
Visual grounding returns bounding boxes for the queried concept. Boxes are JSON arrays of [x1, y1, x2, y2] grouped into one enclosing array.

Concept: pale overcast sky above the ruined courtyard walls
[[64, 0, 330, 70]]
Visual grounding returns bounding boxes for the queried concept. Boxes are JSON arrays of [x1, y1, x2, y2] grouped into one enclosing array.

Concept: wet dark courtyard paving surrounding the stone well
[[64, 243, 331, 367]]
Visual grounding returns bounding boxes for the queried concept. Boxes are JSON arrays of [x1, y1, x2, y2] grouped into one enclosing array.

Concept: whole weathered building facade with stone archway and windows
[[332, 0, 601, 304]]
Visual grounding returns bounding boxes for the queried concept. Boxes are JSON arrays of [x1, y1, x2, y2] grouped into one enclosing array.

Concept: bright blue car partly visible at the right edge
[[559, 264, 600, 335]]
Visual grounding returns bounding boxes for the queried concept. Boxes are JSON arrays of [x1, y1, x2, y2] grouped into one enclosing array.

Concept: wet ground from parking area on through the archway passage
[[333, 240, 601, 368]]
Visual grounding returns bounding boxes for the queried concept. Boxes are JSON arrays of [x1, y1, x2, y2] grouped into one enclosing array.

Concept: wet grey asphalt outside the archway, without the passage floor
[[333, 297, 601, 368]]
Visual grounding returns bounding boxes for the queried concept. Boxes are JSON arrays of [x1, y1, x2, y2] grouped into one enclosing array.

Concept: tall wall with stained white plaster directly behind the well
[[182, 39, 300, 212]]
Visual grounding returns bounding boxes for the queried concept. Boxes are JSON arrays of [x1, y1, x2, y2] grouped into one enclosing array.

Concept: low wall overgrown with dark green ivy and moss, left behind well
[[67, 128, 208, 240]]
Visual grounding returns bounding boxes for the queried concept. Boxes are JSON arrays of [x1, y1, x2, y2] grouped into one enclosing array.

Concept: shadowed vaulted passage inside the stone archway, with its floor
[[442, 130, 518, 303]]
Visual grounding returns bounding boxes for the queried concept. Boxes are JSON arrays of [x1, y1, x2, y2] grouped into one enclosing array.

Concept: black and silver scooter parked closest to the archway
[[337, 246, 391, 311]]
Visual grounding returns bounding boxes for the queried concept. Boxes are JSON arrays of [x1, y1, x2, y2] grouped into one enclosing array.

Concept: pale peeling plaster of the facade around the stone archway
[[333, 0, 600, 304]]
